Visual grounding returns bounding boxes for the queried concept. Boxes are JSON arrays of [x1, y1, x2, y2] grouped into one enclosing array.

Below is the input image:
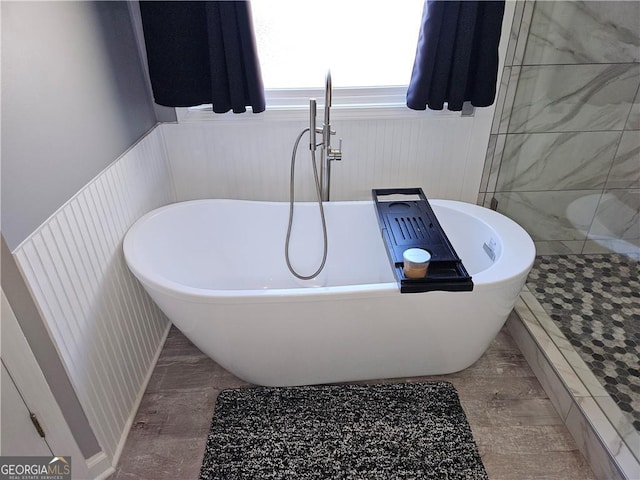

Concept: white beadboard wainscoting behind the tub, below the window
[[162, 108, 493, 203]]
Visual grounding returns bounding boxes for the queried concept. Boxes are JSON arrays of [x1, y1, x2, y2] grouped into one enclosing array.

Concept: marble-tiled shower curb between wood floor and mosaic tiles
[[507, 286, 640, 480]]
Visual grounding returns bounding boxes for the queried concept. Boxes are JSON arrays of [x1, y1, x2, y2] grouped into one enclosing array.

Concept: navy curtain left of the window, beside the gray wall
[[140, 1, 265, 113]]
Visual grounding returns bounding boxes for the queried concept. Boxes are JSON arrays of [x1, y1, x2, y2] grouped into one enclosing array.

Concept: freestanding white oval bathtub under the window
[[124, 200, 535, 386]]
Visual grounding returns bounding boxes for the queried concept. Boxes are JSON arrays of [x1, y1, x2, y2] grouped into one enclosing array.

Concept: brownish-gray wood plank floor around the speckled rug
[[111, 322, 595, 480]]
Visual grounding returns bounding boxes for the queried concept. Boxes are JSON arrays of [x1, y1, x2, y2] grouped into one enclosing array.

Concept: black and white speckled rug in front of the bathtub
[[200, 382, 488, 480]]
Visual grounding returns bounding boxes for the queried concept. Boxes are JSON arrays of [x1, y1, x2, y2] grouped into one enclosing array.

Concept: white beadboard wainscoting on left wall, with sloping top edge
[[13, 127, 175, 464]]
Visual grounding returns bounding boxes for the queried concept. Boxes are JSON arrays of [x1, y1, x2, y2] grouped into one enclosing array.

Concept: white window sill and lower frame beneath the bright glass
[[176, 86, 460, 123]]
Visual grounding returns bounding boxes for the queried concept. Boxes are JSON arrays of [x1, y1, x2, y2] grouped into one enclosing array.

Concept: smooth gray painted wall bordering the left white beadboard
[[0, 1, 156, 457]]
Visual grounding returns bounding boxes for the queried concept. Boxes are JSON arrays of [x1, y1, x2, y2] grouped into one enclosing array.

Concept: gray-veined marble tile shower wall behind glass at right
[[479, 1, 640, 256]]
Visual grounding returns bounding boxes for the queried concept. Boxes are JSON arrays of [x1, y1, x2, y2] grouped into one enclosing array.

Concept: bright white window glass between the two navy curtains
[[251, 0, 423, 89]]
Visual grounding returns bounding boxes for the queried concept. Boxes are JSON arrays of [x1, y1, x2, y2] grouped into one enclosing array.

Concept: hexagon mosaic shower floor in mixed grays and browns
[[527, 254, 640, 431]]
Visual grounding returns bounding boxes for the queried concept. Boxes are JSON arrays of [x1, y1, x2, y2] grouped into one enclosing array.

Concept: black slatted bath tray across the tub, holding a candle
[[372, 188, 473, 293]]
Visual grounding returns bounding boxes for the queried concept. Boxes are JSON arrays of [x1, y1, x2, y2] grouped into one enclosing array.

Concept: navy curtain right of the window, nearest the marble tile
[[407, 0, 504, 111]]
